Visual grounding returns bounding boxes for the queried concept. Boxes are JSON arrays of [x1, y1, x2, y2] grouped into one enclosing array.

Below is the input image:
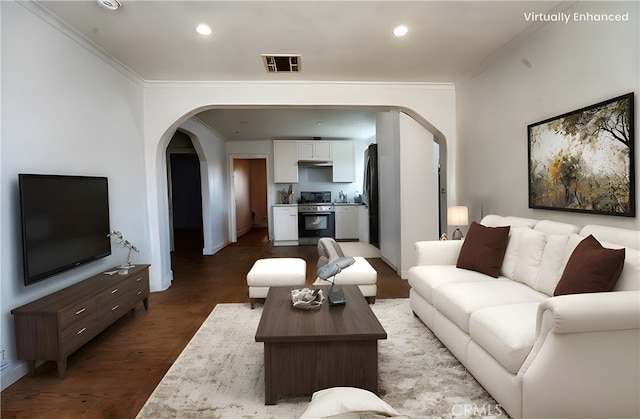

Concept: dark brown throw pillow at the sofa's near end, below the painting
[[553, 235, 625, 296]]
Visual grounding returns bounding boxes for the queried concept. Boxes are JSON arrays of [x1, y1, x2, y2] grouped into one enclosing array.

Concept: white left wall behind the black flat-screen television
[[0, 1, 149, 389]]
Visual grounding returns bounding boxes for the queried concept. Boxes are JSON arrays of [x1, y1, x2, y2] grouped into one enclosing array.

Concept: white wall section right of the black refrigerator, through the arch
[[376, 111, 439, 278]]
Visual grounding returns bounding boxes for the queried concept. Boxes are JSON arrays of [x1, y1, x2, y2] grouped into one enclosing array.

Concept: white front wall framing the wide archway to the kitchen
[[144, 82, 455, 291]]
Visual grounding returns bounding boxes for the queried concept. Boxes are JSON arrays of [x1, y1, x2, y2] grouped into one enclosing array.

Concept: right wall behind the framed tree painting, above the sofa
[[456, 2, 640, 229]]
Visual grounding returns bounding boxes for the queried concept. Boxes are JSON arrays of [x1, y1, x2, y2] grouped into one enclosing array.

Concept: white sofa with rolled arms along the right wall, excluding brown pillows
[[409, 215, 640, 418]]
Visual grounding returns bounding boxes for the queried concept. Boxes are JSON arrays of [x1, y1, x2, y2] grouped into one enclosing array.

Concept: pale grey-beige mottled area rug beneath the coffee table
[[137, 298, 506, 419]]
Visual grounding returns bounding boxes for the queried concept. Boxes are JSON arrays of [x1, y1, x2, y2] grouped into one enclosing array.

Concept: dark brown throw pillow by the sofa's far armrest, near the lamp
[[456, 221, 510, 278]]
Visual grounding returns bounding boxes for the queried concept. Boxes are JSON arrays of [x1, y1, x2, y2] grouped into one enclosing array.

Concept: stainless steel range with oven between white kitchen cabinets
[[298, 192, 336, 246]]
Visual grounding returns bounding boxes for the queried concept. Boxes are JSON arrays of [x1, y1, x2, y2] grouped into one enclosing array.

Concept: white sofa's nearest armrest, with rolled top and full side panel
[[518, 291, 640, 418]]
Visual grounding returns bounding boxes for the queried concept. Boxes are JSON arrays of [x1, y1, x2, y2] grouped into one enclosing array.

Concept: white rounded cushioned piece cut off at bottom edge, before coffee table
[[300, 387, 400, 419]]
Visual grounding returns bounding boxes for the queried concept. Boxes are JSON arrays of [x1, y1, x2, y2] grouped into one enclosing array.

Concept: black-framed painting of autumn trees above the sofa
[[527, 93, 636, 217]]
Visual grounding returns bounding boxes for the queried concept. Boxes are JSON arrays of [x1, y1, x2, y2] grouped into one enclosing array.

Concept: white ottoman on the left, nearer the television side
[[247, 258, 307, 308]]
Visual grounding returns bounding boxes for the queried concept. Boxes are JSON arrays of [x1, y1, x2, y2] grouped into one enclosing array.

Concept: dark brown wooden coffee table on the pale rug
[[256, 285, 387, 404]]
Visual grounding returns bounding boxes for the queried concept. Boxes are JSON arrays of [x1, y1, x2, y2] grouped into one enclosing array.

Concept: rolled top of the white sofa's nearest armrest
[[537, 291, 640, 335]]
